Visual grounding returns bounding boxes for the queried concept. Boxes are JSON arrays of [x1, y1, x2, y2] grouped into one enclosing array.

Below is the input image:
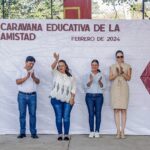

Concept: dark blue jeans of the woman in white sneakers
[[85, 93, 103, 132]]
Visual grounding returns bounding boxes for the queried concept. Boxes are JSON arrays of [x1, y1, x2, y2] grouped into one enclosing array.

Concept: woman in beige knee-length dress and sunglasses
[[109, 50, 131, 139]]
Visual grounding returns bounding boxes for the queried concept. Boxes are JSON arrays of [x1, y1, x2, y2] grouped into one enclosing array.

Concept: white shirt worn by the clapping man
[[16, 68, 37, 93]]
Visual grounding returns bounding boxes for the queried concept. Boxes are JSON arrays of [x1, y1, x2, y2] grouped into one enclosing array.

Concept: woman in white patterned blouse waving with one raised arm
[[51, 53, 76, 141]]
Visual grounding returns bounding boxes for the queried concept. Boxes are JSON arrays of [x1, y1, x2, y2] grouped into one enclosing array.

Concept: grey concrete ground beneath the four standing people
[[0, 135, 150, 150]]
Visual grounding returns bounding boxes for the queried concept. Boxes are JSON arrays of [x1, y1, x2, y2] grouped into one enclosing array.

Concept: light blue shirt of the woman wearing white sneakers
[[83, 72, 106, 94]]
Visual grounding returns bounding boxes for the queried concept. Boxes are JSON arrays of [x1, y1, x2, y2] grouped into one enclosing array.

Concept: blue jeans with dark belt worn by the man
[[18, 92, 37, 134]]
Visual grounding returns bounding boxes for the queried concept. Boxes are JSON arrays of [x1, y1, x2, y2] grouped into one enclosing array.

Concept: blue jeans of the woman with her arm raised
[[51, 98, 72, 135]]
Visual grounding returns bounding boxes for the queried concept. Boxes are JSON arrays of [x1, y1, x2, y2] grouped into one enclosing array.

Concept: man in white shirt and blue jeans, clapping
[[16, 56, 40, 138]]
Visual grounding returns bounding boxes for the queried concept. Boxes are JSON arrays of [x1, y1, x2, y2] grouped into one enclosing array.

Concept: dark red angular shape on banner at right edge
[[141, 62, 150, 94]]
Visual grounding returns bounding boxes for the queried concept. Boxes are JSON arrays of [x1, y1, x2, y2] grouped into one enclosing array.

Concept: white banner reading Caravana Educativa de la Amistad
[[0, 20, 150, 135]]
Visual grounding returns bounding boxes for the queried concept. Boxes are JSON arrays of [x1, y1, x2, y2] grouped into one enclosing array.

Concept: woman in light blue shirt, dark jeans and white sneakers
[[84, 59, 105, 138]]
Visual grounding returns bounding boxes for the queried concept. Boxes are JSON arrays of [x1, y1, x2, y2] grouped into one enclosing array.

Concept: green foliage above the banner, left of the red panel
[[0, 0, 63, 19]]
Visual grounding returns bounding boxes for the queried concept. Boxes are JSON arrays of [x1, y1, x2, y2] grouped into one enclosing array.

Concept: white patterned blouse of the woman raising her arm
[[50, 69, 76, 102]]
